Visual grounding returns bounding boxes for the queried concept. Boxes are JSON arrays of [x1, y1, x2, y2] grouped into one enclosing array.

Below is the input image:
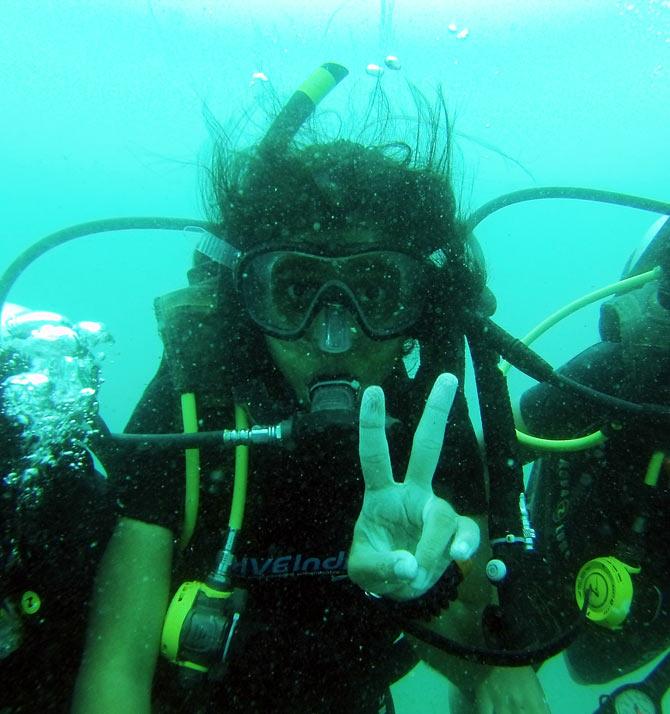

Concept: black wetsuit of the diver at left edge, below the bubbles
[[0, 414, 115, 714]]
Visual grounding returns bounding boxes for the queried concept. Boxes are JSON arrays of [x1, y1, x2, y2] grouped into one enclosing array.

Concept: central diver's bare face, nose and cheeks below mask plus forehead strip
[[266, 230, 405, 404]]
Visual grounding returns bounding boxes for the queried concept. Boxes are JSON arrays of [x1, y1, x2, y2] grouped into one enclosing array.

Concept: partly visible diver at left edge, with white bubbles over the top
[[0, 306, 115, 714]]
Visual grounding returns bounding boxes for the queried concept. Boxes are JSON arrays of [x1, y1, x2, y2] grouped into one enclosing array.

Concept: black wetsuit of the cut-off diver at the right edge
[[522, 342, 670, 683]]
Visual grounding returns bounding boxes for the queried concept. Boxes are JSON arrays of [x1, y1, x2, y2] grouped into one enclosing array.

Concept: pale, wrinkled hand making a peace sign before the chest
[[348, 373, 479, 600]]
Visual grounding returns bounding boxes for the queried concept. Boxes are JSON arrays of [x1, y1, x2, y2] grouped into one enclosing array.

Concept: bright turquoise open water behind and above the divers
[[0, 0, 670, 714]]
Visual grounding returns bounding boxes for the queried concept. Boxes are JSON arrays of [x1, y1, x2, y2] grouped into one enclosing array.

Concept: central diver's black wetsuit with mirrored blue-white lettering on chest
[[120, 356, 485, 714]]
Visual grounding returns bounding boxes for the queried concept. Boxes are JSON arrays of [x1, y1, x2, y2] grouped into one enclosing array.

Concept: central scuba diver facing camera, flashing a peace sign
[[0, 63, 670, 714]]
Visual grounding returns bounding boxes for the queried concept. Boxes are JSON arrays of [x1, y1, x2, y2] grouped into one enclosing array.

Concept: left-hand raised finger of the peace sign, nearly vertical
[[358, 387, 393, 490]]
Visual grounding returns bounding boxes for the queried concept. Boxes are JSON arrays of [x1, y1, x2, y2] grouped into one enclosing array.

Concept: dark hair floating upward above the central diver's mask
[[208, 84, 484, 295]]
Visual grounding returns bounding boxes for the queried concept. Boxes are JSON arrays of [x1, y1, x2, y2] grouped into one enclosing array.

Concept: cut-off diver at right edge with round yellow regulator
[[521, 217, 670, 712]]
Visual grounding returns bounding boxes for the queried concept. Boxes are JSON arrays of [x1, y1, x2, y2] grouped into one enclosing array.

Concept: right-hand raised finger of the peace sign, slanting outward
[[405, 372, 458, 489]]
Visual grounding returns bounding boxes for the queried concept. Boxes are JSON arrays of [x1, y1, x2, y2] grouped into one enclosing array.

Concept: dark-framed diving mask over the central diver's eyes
[[237, 247, 426, 339]]
